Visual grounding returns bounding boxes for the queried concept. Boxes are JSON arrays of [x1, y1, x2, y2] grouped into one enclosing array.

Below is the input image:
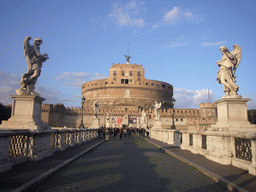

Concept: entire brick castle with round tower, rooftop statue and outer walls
[[42, 58, 217, 130]]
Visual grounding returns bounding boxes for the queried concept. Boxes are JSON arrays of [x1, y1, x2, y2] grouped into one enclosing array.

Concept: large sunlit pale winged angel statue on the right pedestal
[[216, 44, 241, 97]]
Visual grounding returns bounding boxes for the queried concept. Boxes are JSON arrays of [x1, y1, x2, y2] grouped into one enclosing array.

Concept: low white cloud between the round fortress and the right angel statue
[[174, 88, 215, 109]]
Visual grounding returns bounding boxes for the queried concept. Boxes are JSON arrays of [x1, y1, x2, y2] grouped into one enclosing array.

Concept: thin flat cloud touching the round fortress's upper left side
[[55, 72, 108, 88]]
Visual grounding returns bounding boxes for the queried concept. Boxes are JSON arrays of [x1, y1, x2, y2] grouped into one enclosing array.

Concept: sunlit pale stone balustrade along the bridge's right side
[[151, 129, 256, 175]]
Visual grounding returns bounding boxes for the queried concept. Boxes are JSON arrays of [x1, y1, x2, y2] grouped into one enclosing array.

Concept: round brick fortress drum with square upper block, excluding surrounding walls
[[82, 63, 173, 110]]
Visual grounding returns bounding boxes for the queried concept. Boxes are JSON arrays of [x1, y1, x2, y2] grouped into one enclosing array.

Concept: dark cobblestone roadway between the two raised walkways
[[33, 135, 228, 192]]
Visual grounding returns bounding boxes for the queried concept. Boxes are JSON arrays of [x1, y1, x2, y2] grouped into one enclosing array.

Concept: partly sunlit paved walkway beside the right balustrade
[[144, 138, 256, 192]]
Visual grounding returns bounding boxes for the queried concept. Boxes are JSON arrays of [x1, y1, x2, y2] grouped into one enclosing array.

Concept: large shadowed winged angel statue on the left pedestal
[[16, 36, 49, 95]]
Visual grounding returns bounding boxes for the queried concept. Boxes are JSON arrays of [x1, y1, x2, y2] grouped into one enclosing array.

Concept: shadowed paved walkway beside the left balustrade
[[0, 139, 103, 192]]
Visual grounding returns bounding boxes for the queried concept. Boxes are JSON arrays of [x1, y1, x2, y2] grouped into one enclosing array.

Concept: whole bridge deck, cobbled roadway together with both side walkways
[[0, 135, 256, 191]]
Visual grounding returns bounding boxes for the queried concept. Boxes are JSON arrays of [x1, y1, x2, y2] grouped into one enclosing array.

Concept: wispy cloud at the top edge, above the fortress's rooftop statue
[[108, 1, 145, 27]]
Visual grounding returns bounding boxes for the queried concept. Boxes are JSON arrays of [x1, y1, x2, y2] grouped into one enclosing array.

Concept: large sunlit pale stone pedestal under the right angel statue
[[207, 98, 256, 132]]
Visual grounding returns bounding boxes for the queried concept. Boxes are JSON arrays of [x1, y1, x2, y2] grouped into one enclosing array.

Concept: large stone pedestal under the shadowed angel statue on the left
[[0, 95, 51, 130]]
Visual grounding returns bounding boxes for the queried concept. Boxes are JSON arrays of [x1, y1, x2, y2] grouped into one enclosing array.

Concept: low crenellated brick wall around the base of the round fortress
[[42, 103, 217, 130]]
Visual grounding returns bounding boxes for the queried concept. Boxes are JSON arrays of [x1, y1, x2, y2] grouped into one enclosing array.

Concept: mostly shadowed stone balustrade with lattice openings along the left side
[[0, 127, 97, 172]]
